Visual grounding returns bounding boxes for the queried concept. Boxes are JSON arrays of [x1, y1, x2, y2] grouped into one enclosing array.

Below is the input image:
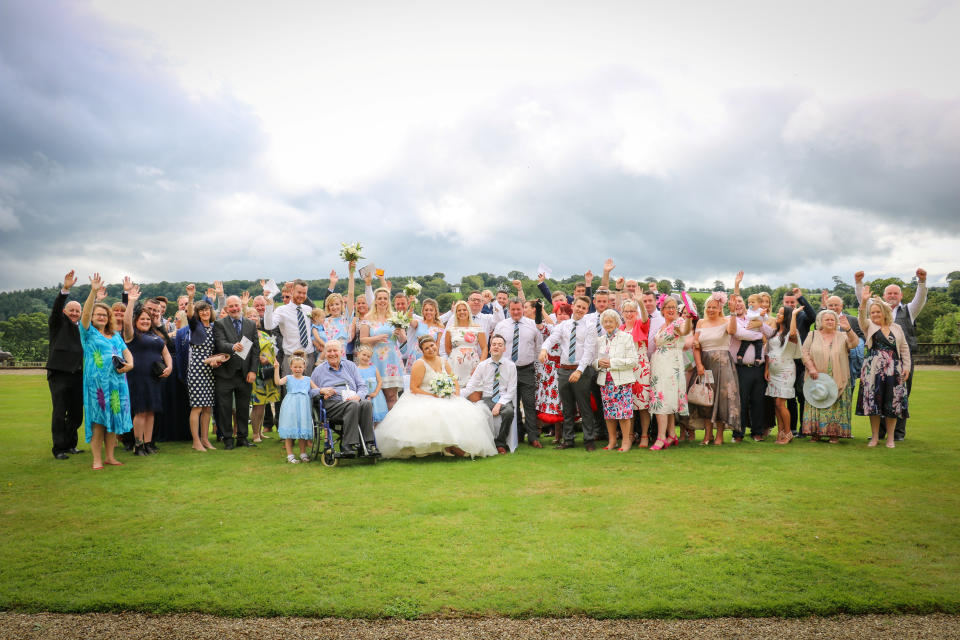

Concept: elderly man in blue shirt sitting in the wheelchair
[[310, 340, 380, 458]]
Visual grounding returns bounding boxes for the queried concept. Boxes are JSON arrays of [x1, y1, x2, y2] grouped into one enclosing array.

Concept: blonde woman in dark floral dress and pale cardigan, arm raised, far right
[[857, 286, 910, 449]]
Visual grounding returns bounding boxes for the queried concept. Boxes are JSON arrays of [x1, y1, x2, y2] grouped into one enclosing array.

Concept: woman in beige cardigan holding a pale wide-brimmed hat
[[801, 309, 857, 444]]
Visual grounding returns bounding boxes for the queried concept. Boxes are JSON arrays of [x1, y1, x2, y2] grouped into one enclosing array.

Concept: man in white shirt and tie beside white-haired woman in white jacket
[[540, 296, 597, 451]]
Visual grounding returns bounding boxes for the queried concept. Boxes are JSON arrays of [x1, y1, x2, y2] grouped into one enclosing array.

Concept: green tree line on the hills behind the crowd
[[0, 271, 960, 361]]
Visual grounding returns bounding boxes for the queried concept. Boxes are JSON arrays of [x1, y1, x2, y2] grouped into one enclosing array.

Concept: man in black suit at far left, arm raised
[[47, 270, 83, 460]]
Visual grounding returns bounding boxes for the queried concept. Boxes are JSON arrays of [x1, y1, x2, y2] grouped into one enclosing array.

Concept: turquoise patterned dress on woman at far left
[[80, 324, 133, 442]]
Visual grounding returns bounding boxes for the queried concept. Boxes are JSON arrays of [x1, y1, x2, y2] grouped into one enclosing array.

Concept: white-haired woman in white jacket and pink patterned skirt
[[593, 309, 637, 451]]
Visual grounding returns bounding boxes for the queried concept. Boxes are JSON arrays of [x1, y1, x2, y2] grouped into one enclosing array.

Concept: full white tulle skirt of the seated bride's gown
[[377, 393, 497, 458]]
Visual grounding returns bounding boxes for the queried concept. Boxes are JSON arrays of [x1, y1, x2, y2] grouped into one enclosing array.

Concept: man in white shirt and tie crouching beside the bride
[[464, 334, 517, 453]]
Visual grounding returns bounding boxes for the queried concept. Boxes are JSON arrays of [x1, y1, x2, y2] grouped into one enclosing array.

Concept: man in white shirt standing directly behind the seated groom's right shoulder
[[498, 298, 543, 449]]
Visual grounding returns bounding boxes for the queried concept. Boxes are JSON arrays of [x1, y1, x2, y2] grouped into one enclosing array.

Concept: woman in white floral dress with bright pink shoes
[[650, 298, 691, 451]]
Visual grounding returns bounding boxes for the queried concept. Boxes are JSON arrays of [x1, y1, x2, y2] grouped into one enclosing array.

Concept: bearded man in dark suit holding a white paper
[[213, 296, 260, 449]]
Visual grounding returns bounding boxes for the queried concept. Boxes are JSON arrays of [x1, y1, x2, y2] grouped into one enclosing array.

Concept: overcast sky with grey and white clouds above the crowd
[[0, 0, 960, 290]]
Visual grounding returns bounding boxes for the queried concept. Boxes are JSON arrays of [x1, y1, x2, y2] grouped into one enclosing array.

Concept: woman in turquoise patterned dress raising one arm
[[80, 273, 133, 471]]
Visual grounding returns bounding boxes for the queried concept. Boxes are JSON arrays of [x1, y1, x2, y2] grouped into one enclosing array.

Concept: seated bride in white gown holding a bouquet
[[376, 335, 497, 458]]
